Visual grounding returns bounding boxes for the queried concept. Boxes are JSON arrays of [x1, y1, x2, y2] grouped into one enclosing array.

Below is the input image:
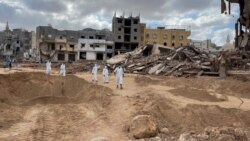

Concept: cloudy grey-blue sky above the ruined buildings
[[0, 0, 239, 45]]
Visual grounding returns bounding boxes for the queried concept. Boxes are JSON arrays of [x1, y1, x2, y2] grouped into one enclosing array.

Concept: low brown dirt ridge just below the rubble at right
[[135, 76, 250, 99]]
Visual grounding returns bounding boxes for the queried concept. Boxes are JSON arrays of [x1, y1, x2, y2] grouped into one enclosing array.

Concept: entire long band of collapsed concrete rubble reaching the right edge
[[107, 45, 250, 77]]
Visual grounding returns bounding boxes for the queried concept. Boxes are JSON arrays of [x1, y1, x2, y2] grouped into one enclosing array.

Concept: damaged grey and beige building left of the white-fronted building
[[36, 26, 78, 62]]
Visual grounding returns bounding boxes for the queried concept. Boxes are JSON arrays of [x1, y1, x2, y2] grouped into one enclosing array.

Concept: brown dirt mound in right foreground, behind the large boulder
[[137, 96, 250, 136]]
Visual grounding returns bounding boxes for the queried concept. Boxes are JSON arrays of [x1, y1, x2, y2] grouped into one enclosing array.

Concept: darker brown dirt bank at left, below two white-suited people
[[0, 73, 111, 105]]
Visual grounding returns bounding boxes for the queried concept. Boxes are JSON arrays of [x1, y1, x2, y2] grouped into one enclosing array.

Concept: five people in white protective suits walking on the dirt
[[45, 61, 124, 89]]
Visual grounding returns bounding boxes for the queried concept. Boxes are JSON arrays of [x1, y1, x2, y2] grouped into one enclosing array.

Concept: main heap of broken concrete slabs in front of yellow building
[[107, 46, 218, 76]]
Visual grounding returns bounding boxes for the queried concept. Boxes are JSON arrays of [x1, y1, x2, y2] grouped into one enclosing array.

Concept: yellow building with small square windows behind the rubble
[[144, 27, 191, 47]]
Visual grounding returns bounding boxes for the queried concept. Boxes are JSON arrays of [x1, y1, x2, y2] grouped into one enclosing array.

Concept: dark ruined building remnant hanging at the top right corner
[[221, 0, 250, 51]]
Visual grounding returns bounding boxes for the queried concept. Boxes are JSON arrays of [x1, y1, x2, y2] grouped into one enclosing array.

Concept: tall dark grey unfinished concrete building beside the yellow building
[[112, 14, 145, 54]]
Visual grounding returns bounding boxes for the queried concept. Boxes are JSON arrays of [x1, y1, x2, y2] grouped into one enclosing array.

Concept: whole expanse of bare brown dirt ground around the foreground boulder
[[0, 69, 250, 141]]
